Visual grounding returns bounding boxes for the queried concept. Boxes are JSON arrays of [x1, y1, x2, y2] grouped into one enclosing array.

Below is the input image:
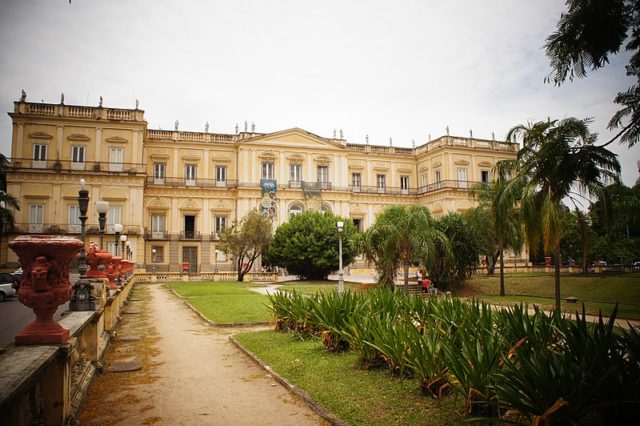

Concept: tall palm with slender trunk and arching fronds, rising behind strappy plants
[[496, 117, 620, 308]]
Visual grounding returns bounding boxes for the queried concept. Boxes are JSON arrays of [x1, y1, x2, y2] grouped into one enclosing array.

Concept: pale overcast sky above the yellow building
[[0, 0, 640, 185]]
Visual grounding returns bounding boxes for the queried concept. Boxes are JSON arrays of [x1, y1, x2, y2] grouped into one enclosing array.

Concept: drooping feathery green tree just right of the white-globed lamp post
[[356, 205, 448, 291]]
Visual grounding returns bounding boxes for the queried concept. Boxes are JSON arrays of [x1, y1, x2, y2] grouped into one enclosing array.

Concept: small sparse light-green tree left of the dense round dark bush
[[220, 210, 272, 281]]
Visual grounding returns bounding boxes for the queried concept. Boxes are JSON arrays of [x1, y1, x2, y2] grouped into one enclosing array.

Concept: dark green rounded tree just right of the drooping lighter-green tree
[[427, 212, 482, 290]]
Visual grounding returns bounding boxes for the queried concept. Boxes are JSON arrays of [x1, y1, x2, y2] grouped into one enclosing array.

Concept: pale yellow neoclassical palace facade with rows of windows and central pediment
[[0, 98, 518, 272]]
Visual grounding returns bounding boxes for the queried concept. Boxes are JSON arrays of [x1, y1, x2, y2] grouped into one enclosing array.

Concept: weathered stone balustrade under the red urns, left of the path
[[0, 276, 136, 425]]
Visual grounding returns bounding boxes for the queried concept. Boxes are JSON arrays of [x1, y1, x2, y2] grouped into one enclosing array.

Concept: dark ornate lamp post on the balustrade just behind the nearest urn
[[69, 179, 96, 311]]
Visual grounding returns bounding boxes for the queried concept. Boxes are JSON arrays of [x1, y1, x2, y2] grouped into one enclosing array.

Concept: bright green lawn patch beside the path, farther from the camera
[[167, 281, 271, 324]]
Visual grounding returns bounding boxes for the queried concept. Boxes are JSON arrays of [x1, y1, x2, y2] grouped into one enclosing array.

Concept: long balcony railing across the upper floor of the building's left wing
[[10, 158, 146, 175]]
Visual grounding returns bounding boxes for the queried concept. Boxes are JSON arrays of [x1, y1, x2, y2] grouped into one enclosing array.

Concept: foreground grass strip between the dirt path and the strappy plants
[[236, 331, 464, 425]]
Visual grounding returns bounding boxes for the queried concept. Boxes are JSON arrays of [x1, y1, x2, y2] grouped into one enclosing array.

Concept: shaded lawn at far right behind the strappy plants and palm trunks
[[459, 273, 640, 319]]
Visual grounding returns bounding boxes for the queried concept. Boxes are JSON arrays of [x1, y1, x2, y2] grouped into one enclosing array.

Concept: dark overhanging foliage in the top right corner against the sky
[[545, 0, 640, 147]]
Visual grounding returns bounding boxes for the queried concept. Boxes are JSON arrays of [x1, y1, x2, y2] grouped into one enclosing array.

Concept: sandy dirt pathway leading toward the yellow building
[[80, 285, 323, 425]]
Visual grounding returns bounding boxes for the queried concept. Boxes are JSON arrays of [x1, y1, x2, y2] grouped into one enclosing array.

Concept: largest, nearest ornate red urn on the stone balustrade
[[9, 235, 84, 345]]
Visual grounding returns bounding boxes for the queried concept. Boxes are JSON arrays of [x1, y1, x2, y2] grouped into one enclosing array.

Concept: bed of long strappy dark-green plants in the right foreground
[[269, 288, 640, 425]]
